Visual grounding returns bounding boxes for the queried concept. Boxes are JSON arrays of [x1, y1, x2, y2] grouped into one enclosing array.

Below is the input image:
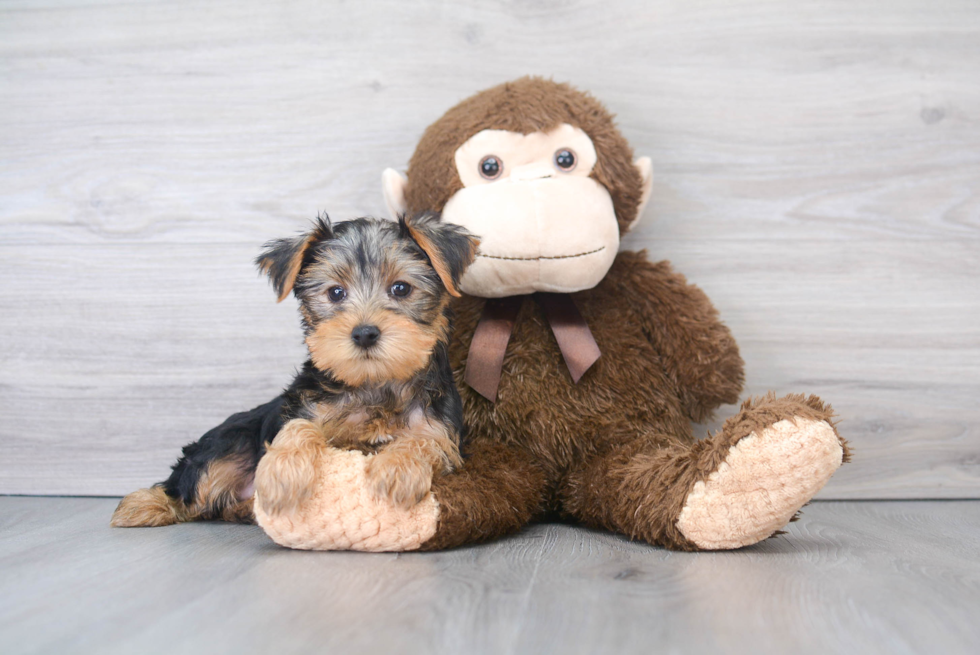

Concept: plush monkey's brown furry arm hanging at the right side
[[617, 251, 745, 422]]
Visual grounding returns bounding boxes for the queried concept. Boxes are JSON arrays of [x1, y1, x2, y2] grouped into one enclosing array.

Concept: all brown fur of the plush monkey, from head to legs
[[390, 77, 847, 550]]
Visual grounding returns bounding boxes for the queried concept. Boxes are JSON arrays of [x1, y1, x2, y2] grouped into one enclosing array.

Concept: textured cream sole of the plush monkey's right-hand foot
[[677, 400, 846, 550]]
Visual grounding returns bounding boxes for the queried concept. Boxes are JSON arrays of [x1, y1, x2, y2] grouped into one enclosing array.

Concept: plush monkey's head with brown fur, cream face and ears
[[383, 77, 653, 298]]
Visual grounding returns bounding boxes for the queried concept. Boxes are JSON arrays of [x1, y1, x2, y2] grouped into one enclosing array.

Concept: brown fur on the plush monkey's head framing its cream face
[[405, 77, 643, 231]]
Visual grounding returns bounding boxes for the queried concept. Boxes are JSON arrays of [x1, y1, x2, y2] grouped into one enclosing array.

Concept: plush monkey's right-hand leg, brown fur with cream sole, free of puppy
[[561, 395, 848, 550]]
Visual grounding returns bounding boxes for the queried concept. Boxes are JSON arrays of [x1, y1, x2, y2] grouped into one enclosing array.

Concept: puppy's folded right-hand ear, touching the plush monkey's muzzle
[[398, 212, 480, 297]]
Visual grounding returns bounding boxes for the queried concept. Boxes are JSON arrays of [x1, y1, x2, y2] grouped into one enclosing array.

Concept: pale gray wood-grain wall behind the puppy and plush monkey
[[0, 0, 980, 498]]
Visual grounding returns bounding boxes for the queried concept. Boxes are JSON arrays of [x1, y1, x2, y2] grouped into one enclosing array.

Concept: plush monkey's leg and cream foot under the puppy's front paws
[[255, 439, 545, 551]]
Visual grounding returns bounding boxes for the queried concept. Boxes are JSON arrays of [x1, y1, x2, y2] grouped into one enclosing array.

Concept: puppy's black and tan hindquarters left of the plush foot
[[110, 396, 282, 528]]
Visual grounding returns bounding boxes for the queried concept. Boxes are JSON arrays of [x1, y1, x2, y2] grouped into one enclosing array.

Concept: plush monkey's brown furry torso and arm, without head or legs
[[450, 253, 742, 478]]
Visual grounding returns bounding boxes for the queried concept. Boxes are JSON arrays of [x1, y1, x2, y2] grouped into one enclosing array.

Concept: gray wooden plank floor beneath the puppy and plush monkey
[[0, 497, 980, 655]]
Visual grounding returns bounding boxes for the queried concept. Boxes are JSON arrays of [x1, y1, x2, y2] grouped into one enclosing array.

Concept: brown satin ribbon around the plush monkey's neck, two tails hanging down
[[465, 293, 602, 402]]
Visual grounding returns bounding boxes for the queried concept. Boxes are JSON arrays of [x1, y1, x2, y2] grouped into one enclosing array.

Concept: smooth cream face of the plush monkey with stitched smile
[[442, 124, 619, 298]]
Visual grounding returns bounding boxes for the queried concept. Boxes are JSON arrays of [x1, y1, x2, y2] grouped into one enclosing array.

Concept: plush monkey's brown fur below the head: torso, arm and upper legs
[[414, 252, 742, 548]]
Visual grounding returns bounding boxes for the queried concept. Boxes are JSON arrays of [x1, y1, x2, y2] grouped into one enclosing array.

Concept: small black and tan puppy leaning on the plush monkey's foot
[[112, 213, 478, 527]]
